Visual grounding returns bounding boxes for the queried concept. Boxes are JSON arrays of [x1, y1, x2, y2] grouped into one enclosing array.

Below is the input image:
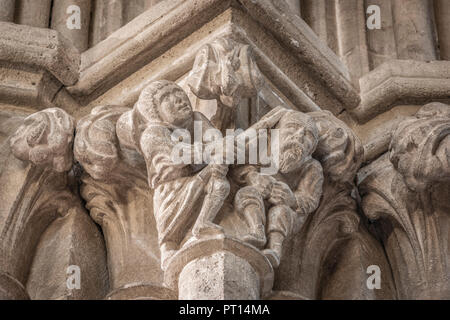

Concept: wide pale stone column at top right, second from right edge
[[392, 0, 436, 61]]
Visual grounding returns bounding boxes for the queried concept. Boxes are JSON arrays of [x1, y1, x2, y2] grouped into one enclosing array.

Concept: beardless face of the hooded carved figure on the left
[[159, 88, 193, 126]]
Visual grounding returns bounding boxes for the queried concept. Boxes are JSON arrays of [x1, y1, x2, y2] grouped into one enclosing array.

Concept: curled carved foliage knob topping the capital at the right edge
[[390, 103, 450, 191]]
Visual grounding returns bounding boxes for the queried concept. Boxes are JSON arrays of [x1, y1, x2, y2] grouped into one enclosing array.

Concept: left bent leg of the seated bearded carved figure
[[234, 187, 267, 249]]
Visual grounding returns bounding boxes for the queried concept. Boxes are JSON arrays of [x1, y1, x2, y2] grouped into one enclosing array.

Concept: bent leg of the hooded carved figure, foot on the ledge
[[192, 169, 230, 238]]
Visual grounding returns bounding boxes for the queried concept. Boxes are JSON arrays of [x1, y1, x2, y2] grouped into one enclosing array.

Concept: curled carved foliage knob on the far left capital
[[10, 108, 75, 172]]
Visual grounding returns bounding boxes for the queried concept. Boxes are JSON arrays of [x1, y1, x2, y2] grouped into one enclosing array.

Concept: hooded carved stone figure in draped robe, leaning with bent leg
[[117, 81, 230, 269]]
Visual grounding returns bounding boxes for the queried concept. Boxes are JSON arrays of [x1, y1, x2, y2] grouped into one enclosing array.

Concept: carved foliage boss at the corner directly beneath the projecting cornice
[[188, 37, 263, 107]]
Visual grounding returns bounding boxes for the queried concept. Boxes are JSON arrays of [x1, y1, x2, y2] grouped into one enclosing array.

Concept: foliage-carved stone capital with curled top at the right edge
[[359, 103, 450, 299]]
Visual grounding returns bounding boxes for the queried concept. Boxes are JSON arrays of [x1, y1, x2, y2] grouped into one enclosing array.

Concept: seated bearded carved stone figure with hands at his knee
[[235, 111, 323, 267]]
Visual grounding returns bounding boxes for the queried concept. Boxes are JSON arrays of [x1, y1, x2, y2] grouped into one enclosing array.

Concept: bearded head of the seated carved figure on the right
[[276, 111, 319, 173]]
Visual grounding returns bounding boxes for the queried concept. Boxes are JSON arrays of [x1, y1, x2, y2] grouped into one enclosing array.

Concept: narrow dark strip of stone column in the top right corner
[[434, 0, 450, 60]]
